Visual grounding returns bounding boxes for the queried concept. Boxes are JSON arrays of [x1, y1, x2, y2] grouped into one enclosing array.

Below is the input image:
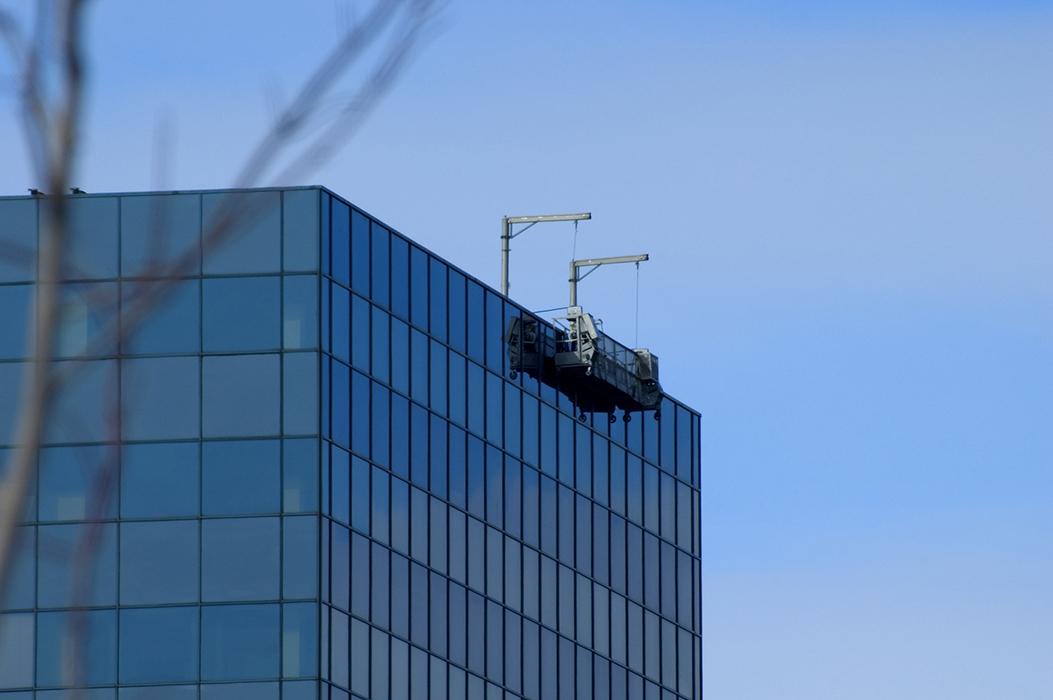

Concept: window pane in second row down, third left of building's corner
[[121, 280, 201, 355]]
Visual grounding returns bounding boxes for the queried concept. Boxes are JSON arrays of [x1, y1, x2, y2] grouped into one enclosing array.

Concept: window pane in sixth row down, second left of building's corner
[[201, 605, 279, 681]]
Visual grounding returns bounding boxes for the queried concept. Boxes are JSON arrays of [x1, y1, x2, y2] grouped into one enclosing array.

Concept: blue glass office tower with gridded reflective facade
[[0, 187, 701, 700]]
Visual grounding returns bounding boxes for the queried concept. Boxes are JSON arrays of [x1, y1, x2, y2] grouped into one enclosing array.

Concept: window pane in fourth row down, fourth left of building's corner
[[37, 446, 112, 520]]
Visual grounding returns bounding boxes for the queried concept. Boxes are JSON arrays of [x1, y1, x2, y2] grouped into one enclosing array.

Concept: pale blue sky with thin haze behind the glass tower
[[0, 0, 1053, 700]]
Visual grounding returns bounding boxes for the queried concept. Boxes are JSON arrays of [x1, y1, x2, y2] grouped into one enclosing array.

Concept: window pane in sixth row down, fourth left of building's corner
[[37, 611, 117, 686]]
